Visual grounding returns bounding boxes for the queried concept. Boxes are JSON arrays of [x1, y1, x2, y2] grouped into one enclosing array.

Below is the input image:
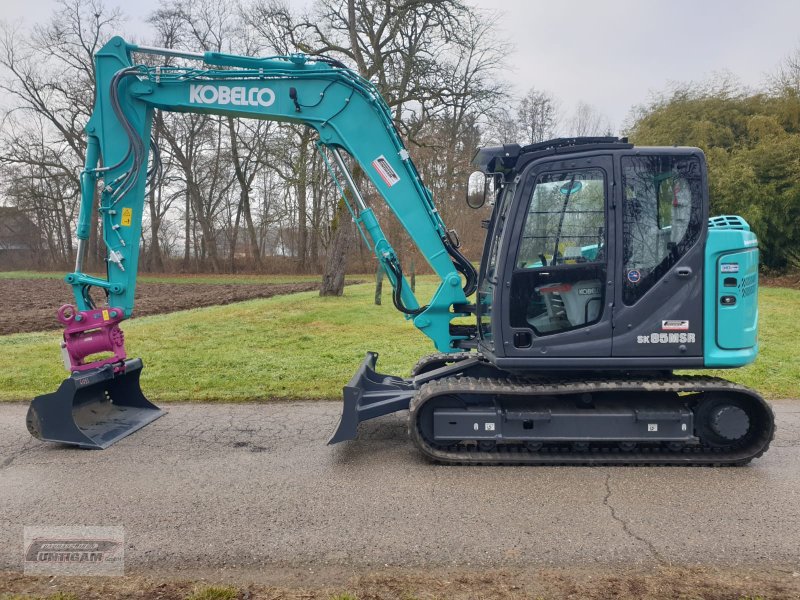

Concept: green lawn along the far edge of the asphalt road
[[0, 278, 800, 402]]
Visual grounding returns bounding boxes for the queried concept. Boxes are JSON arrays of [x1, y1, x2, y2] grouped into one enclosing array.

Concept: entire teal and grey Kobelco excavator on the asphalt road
[[27, 37, 775, 466]]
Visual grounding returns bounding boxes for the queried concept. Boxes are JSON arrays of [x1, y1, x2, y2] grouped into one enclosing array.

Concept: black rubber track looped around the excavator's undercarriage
[[408, 376, 775, 467]]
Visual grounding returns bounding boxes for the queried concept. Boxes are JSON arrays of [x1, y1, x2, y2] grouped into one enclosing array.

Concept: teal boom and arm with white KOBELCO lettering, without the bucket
[[67, 37, 476, 360]]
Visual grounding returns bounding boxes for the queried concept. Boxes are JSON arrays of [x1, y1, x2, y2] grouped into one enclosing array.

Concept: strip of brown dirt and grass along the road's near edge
[[0, 566, 800, 600]]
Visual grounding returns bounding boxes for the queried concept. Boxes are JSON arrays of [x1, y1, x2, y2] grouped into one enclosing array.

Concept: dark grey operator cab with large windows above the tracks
[[470, 138, 708, 371]]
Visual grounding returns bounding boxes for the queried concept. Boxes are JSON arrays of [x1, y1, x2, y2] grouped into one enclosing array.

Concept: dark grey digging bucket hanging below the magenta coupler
[[27, 358, 164, 449]]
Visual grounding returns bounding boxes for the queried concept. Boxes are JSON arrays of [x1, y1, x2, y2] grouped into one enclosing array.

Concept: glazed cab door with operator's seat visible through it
[[497, 155, 615, 358]]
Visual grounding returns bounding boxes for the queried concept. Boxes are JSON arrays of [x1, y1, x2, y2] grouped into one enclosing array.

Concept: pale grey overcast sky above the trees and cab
[[2, 0, 800, 129]]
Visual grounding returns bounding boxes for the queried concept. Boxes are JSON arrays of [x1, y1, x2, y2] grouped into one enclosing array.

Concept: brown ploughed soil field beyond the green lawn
[[0, 279, 355, 335]]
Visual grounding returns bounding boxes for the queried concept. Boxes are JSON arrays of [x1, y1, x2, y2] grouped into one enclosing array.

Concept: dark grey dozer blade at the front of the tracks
[[328, 352, 415, 444]]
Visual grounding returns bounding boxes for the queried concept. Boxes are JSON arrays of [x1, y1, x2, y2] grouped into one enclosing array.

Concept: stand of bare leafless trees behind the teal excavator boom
[[0, 0, 506, 276]]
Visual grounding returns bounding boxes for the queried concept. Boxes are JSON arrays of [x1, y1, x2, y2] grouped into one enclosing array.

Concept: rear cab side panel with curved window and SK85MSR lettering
[[612, 148, 708, 359]]
